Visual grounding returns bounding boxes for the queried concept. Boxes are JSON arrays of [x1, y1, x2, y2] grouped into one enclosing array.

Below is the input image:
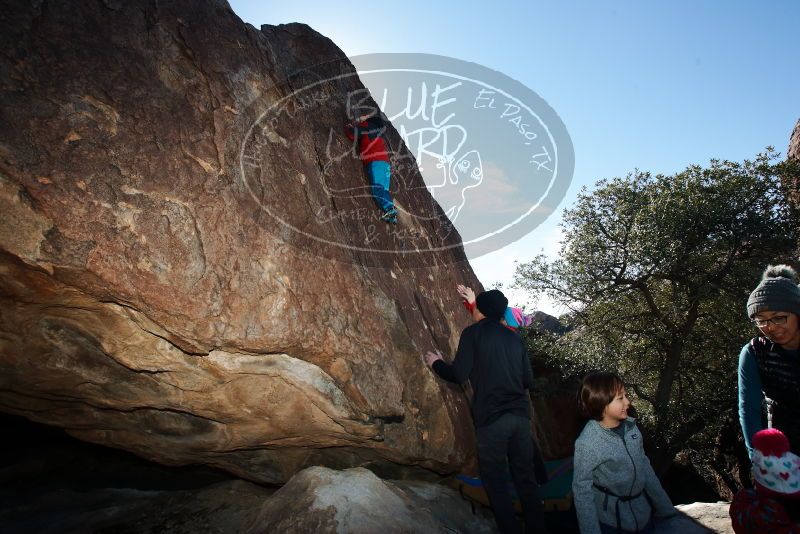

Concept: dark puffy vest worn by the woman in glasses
[[750, 337, 800, 451]]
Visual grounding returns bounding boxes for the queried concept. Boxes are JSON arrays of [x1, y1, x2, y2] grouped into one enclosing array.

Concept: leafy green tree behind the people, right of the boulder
[[515, 148, 798, 469]]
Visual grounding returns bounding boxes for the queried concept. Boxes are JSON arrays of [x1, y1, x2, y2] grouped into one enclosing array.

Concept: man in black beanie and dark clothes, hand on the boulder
[[423, 289, 544, 533]]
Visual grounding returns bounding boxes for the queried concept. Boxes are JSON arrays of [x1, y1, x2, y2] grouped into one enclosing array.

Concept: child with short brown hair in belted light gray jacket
[[572, 373, 677, 534]]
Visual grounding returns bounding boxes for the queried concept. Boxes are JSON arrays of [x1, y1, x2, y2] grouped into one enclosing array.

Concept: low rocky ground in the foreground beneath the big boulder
[[0, 467, 497, 534]]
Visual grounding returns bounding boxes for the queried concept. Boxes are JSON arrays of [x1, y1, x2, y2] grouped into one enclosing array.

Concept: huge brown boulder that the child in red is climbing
[[0, 0, 479, 482]]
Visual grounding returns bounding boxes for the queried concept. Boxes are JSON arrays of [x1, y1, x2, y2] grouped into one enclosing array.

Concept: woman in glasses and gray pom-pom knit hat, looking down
[[739, 265, 800, 456]]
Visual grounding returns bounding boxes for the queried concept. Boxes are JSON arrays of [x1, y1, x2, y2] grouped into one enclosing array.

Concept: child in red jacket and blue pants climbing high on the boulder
[[344, 110, 397, 224]]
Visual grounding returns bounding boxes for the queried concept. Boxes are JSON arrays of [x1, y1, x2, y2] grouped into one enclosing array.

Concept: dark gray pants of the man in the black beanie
[[476, 414, 544, 534]]
